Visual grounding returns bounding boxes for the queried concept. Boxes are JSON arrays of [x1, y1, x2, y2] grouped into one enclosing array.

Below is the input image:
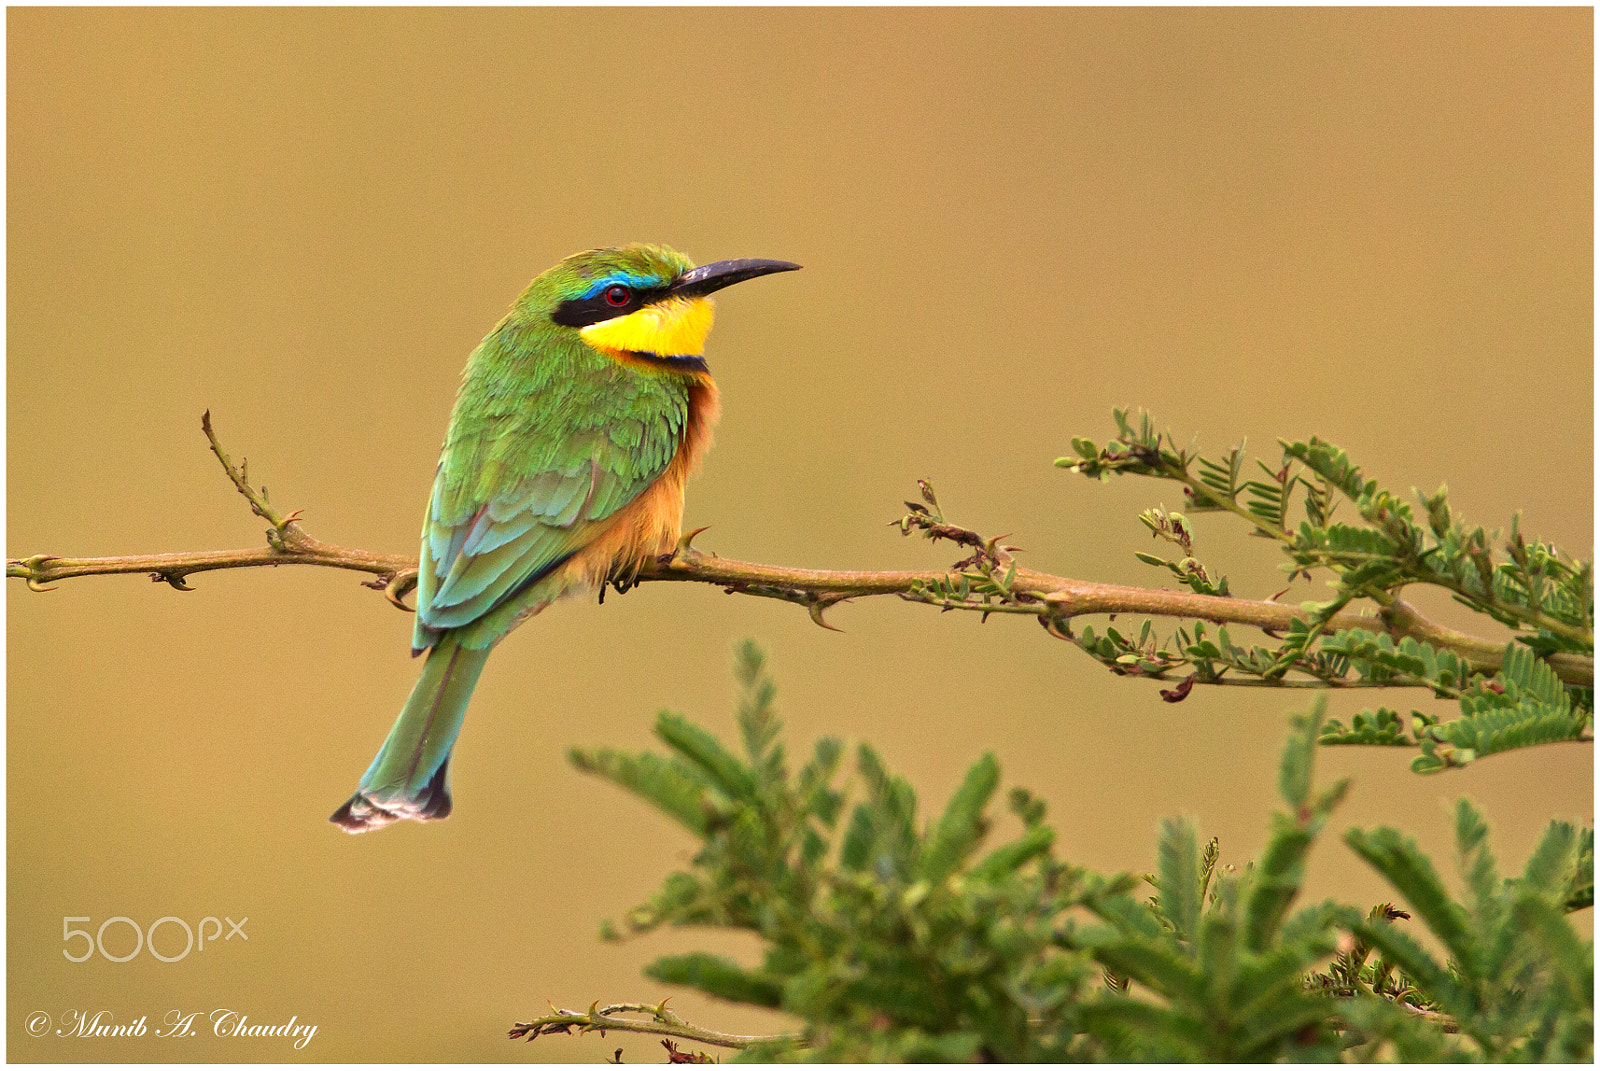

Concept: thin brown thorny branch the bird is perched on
[[6, 413, 1594, 698]]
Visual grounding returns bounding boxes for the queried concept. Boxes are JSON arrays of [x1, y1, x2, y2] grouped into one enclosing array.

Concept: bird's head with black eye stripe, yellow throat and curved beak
[[517, 243, 800, 365]]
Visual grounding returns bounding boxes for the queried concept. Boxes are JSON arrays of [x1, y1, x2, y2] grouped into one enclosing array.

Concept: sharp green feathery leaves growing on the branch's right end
[[1056, 410, 1594, 773]]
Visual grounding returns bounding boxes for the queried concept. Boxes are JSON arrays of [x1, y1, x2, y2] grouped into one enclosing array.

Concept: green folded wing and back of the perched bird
[[413, 354, 688, 650]]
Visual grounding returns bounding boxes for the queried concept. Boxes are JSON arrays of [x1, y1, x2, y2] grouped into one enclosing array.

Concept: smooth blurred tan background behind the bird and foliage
[[6, 10, 1594, 1061]]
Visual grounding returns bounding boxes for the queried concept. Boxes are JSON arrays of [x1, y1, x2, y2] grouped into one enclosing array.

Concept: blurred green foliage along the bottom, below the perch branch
[[571, 644, 1594, 1061]]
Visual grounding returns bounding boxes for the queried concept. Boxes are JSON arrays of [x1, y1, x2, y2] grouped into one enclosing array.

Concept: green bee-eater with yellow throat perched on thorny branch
[[330, 243, 800, 832]]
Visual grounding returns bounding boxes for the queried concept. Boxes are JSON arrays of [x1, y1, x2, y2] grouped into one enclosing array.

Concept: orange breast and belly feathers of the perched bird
[[563, 373, 722, 589]]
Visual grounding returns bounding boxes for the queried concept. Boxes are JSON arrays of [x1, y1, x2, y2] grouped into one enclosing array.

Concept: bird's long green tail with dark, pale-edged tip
[[328, 634, 490, 832]]
